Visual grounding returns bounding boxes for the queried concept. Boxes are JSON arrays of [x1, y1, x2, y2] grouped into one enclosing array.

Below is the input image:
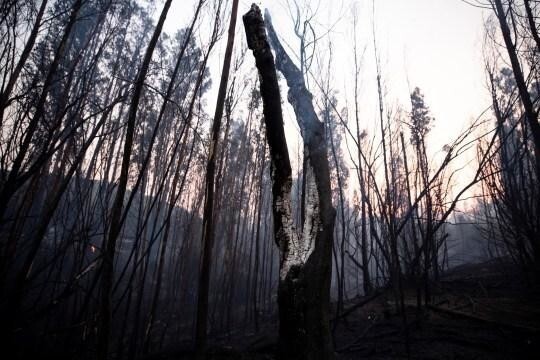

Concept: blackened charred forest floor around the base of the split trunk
[[148, 262, 540, 360]]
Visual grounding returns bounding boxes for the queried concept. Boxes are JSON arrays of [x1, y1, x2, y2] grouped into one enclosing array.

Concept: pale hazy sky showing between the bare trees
[[165, 0, 490, 201]]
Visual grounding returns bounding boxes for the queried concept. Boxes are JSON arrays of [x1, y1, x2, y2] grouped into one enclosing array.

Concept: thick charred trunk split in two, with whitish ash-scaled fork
[[243, 4, 335, 359]]
